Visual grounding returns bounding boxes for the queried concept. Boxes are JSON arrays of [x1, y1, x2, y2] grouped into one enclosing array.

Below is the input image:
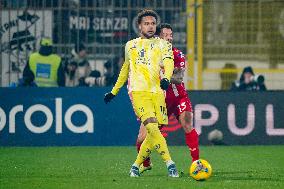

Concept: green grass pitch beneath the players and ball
[[0, 146, 284, 189]]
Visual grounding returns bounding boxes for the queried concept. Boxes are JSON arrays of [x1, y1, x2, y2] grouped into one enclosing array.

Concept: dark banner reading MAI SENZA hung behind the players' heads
[[67, 10, 186, 44]]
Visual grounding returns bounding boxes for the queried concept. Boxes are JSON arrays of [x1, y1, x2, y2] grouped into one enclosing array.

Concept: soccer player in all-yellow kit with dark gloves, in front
[[104, 10, 179, 177]]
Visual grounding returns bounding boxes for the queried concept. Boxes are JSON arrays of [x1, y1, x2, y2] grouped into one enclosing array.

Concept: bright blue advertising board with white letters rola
[[0, 88, 138, 146]]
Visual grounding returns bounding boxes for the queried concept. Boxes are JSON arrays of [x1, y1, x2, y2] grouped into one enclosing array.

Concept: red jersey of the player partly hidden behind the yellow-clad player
[[166, 48, 187, 97]]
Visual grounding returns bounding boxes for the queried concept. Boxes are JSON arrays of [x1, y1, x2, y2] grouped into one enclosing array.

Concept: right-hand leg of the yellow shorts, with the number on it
[[153, 93, 168, 125]]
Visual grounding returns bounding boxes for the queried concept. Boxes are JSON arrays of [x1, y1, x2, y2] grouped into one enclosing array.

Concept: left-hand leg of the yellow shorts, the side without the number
[[132, 92, 156, 123]]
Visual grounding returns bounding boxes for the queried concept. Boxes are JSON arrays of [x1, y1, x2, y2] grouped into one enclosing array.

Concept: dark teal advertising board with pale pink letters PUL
[[165, 91, 284, 145]]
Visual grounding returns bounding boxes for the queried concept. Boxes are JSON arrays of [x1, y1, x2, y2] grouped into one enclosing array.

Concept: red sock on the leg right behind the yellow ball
[[185, 129, 199, 162]]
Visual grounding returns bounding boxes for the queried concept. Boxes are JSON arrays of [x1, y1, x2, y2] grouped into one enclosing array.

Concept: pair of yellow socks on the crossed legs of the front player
[[135, 123, 171, 165]]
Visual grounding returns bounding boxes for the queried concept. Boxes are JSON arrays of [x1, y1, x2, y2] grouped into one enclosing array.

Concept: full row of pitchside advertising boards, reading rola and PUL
[[0, 88, 284, 146]]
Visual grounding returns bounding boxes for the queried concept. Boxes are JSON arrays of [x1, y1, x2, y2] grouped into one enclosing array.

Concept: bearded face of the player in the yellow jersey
[[139, 16, 157, 39]]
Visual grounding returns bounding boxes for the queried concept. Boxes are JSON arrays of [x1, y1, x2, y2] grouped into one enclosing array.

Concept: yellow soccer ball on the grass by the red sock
[[189, 159, 212, 181]]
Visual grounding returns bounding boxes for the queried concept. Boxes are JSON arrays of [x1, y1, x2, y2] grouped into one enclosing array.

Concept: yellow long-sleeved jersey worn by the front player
[[111, 37, 174, 95]]
